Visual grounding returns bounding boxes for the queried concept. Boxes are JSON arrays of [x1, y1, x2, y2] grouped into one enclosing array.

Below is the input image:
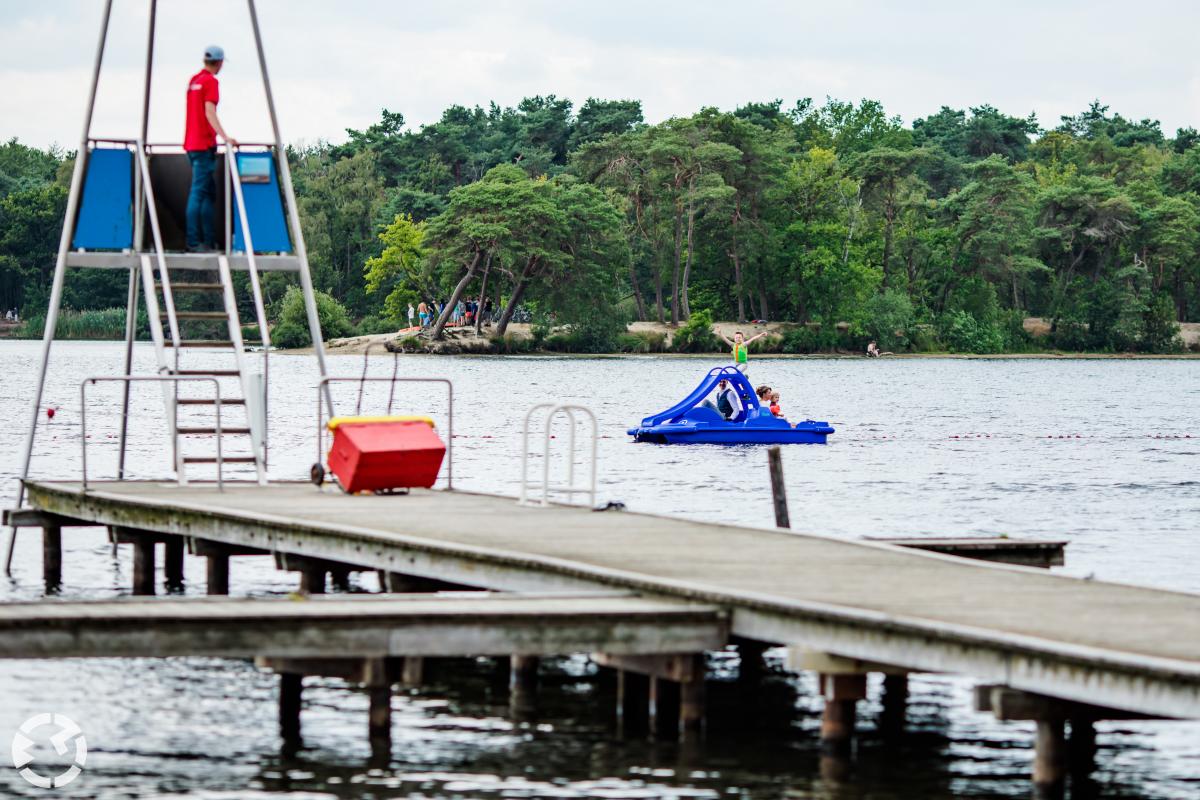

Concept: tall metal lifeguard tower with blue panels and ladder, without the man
[[10, 0, 325, 525]]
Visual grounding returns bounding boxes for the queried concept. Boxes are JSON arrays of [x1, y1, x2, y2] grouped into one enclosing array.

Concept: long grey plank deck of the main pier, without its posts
[[21, 481, 1200, 717]]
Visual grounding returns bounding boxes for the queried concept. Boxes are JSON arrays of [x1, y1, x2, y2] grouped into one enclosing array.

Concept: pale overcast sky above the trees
[[0, 0, 1200, 148]]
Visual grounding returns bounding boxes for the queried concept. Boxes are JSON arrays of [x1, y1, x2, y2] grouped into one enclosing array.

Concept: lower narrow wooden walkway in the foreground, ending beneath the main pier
[[0, 593, 728, 658]]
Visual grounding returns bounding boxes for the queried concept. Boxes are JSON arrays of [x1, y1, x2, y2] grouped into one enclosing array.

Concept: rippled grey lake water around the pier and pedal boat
[[0, 342, 1200, 800]]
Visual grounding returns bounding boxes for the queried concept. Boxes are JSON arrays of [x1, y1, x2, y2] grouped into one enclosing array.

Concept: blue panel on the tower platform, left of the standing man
[[71, 148, 133, 249]]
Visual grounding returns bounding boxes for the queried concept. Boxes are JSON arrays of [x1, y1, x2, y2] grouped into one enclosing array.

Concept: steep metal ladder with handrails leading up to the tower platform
[[136, 142, 271, 485]]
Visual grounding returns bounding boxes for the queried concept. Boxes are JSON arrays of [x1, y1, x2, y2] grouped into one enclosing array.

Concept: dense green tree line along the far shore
[[0, 96, 1200, 353]]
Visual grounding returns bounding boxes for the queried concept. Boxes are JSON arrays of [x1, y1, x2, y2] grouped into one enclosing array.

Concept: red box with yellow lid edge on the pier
[[329, 417, 446, 494]]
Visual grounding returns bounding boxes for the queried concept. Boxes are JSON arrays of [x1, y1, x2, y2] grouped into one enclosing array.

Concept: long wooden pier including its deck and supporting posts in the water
[[9, 481, 1200, 794]]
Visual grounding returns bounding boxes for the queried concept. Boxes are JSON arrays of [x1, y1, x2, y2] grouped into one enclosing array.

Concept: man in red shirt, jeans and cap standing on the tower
[[184, 44, 238, 253]]
